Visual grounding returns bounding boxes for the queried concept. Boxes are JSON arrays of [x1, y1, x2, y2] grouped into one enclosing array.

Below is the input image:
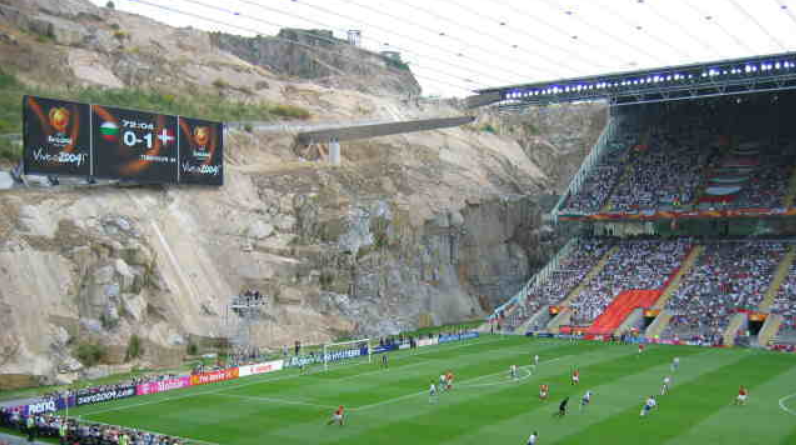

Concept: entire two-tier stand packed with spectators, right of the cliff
[[488, 93, 796, 354]]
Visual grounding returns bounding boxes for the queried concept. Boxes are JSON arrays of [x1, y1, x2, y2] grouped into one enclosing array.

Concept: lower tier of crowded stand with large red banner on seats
[[498, 237, 796, 342]]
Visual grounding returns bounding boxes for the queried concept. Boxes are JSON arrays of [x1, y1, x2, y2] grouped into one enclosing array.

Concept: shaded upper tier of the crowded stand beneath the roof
[[558, 93, 796, 219]]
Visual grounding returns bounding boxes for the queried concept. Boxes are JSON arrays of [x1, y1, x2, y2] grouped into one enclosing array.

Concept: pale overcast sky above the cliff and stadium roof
[[91, 0, 796, 96]]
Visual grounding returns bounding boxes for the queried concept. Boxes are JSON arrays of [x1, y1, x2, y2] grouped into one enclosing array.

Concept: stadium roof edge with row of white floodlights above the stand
[[471, 52, 796, 109]]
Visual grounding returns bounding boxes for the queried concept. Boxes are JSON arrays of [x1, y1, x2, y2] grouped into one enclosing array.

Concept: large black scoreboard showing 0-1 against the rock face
[[23, 96, 224, 185]]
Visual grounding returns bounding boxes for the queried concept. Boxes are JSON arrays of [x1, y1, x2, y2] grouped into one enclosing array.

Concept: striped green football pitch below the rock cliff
[[63, 336, 796, 445]]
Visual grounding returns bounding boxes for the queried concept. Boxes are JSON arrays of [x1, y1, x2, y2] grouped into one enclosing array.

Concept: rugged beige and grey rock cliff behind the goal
[[0, 0, 602, 385]]
